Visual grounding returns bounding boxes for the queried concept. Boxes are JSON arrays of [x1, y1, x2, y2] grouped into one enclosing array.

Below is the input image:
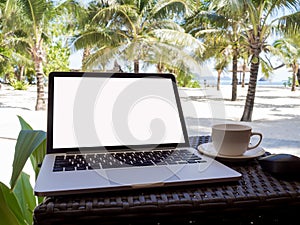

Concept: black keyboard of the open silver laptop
[[53, 149, 206, 172]]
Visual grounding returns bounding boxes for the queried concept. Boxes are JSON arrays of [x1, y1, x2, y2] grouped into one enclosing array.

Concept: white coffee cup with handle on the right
[[211, 123, 262, 156]]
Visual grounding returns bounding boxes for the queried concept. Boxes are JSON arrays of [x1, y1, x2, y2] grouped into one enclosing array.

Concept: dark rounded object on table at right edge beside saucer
[[258, 153, 300, 178]]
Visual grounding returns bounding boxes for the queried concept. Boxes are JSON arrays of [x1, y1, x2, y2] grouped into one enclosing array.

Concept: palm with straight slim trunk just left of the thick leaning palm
[[188, 0, 244, 101]]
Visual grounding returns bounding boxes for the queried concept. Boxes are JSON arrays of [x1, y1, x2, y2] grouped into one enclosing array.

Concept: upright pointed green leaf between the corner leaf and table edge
[[13, 172, 36, 224]]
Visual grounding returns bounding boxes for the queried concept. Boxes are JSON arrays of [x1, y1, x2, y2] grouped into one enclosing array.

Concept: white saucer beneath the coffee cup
[[198, 142, 265, 160]]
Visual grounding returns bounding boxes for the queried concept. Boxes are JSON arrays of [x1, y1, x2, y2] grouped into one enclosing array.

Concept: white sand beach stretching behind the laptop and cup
[[0, 82, 300, 185]]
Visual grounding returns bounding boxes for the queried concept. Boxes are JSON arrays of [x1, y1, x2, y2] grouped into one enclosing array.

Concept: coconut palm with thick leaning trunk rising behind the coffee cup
[[206, 0, 300, 121]]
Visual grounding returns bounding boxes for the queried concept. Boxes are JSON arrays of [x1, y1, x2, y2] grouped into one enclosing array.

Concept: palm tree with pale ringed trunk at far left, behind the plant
[[2, 0, 72, 110]]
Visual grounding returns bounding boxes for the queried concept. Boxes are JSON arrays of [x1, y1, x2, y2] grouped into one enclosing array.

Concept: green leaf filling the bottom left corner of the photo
[[0, 182, 24, 225]]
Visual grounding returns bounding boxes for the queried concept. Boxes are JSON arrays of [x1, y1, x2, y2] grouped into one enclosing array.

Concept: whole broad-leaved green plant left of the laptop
[[0, 116, 46, 225]]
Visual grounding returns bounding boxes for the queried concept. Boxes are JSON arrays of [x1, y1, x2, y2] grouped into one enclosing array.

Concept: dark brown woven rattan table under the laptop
[[33, 136, 300, 225]]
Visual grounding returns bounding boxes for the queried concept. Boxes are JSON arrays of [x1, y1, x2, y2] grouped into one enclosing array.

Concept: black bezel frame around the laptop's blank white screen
[[47, 72, 190, 154]]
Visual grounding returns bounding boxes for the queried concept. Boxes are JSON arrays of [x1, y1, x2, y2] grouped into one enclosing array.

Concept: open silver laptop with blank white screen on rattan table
[[34, 72, 241, 196]]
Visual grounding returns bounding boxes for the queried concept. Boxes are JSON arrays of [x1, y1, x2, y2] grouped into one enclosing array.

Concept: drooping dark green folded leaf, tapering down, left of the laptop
[[10, 130, 46, 189]]
